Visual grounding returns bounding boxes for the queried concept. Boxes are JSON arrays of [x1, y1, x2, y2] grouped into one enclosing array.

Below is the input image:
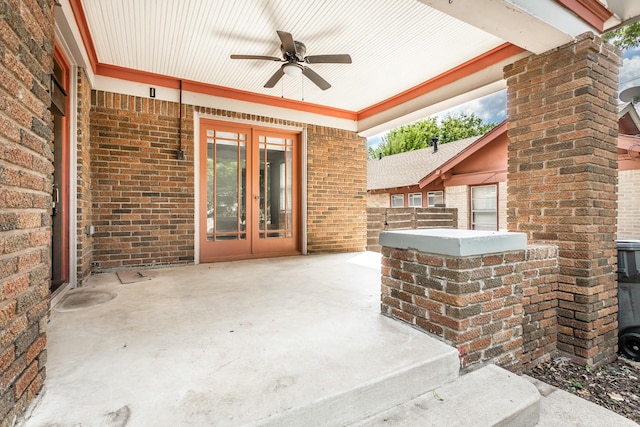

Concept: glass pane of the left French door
[[207, 129, 247, 241]]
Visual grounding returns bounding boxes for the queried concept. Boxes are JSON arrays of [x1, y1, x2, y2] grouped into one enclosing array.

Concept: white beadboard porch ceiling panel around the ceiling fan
[[77, 0, 504, 111]]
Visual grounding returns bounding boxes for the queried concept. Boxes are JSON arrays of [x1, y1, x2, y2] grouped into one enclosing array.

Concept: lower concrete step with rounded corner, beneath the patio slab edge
[[354, 365, 540, 427]]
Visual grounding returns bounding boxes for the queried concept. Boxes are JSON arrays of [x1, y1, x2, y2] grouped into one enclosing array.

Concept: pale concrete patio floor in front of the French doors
[[25, 253, 458, 426]]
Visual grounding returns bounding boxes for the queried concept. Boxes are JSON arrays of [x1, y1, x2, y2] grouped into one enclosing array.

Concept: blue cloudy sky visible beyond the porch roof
[[367, 47, 640, 147]]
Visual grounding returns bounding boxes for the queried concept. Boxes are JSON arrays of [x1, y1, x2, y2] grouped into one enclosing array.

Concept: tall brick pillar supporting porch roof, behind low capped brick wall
[[504, 34, 621, 365]]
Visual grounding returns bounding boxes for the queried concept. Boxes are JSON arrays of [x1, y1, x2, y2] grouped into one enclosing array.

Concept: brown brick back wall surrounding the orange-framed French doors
[[90, 97, 367, 270]]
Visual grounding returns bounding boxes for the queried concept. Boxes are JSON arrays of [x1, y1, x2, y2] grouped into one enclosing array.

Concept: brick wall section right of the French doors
[[307, 125, 367, 252]]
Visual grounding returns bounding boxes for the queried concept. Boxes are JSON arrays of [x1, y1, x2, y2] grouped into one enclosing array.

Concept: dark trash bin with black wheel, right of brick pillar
[[617, 240, 640, 361]]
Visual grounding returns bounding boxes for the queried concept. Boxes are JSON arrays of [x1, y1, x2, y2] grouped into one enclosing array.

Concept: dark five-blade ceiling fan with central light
[[231, 31, 351, 90]]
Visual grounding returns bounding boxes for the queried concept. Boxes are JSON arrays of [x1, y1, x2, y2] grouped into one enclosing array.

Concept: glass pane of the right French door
[[258, 135, 293, 239]]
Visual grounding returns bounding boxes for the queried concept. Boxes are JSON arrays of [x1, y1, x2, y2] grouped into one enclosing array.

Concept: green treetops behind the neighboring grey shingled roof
[[368, 113, 495, 159]]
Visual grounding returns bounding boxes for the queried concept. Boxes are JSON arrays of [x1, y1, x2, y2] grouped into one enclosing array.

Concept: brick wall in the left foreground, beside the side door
[[0, 0, 54, 426]]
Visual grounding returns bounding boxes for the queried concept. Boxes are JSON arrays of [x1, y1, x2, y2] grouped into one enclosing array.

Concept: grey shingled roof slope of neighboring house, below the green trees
[[367, 136, 480, 190]]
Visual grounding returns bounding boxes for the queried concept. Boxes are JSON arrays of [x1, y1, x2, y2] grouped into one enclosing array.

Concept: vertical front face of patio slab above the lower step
[[257, 336, 460, 427]]
